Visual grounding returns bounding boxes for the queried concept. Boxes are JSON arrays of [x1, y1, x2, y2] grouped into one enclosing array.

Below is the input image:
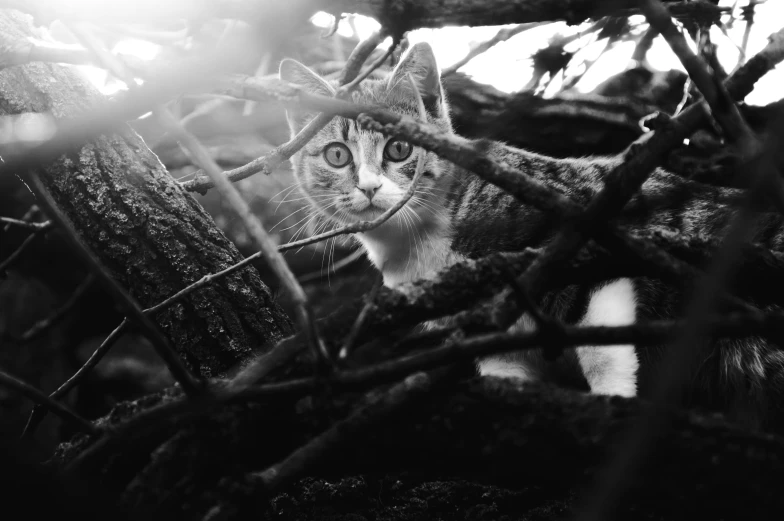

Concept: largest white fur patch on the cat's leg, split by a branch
[[577, 279, 640, 396]]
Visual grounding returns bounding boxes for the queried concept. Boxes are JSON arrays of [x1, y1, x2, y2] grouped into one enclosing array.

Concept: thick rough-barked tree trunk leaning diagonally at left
[[0, 10, 291, 376]]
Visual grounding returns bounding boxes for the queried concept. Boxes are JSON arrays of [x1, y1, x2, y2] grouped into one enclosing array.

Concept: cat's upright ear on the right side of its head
[[387, 42, 447, 117]]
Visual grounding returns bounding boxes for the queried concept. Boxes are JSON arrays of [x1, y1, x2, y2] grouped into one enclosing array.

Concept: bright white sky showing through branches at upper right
[[313, 0, 784, 105]]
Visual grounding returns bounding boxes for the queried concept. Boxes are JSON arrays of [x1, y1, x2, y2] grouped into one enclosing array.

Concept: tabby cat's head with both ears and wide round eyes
[[280, 44, 452, 230]]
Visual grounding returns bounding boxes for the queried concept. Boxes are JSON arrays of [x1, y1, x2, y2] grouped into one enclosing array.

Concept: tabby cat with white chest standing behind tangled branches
[[280, 43, 784, 427]]
